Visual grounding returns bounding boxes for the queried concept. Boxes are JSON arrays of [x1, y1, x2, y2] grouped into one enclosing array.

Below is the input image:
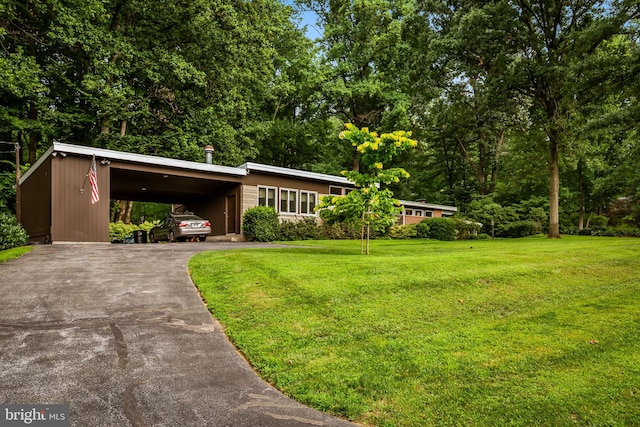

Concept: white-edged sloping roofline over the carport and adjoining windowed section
[[20, 142, 351, 185]]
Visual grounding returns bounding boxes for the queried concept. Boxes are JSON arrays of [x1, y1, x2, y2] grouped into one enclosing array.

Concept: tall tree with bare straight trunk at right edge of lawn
[[418, 0, 640, 238]]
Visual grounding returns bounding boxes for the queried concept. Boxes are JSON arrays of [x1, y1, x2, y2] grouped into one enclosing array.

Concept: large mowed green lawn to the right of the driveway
[[190, 237, 640, 426]]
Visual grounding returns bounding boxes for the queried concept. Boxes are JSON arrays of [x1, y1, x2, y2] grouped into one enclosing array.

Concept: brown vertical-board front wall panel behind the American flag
[[51, 156, 110, 242]]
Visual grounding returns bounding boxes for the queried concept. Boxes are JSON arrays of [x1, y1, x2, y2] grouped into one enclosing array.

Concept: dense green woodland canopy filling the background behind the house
[[0, 0, 640, 237]]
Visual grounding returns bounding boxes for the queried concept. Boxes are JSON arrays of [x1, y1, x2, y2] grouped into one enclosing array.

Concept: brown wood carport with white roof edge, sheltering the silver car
[[20, 143, 246, 242]]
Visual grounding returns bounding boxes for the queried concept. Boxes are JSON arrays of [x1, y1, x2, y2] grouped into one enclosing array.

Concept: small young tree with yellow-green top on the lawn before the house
[[316, 123, 417, 255]]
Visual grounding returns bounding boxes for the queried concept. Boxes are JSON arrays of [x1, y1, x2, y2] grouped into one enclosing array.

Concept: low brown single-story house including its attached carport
[[20, 142, 456, 243]]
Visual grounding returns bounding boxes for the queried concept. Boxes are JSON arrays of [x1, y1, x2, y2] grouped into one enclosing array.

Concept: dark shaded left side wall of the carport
[[20, 158, 51, 242]]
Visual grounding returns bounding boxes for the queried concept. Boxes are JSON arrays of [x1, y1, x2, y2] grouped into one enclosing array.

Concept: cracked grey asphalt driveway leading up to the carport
[[0, 242, 353, 427]]
